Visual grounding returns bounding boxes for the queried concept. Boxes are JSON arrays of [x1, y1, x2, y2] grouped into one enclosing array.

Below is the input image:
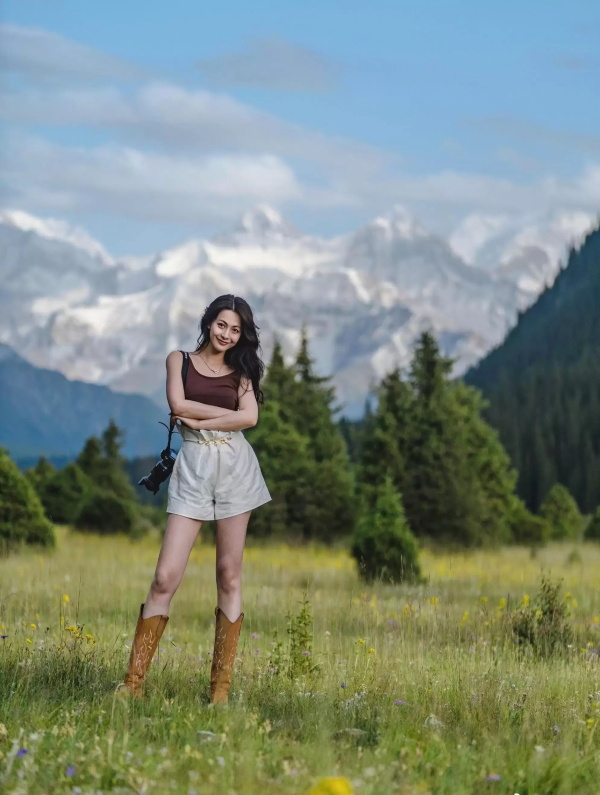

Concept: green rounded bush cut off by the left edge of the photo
[[0, 448, 56, 552]]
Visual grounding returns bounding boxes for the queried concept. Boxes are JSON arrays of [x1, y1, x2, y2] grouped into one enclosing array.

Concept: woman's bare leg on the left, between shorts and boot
[[142, 513, 202, 618]]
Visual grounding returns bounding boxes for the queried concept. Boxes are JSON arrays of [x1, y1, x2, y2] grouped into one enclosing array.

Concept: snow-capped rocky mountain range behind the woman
[[0, 206, 592, 415]]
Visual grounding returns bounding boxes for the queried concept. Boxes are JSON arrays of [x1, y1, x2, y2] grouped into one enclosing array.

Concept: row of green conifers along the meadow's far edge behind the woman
[[0, 330, 600, 564]]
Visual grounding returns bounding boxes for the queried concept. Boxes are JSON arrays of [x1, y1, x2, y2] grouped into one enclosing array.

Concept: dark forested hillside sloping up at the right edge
[[465, 221, 600, 511]]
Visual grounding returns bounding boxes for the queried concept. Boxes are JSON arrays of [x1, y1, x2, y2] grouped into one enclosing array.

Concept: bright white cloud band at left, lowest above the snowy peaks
[[4, 137, 301, 224]]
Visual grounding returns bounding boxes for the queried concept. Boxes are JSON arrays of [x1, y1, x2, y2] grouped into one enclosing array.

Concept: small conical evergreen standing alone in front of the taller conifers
[[351, 476, 421, 583]]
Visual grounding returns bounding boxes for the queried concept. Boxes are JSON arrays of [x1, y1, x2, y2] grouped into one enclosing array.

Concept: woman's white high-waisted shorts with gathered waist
[[167, 424, 271, 522]]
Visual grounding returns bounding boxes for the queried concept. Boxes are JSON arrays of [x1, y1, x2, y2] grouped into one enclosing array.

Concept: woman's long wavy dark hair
[[195, 295, 265, 403]]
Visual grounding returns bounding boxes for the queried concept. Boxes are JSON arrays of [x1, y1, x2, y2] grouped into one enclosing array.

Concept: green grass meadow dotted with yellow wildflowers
[[0, 528, 600, 795]]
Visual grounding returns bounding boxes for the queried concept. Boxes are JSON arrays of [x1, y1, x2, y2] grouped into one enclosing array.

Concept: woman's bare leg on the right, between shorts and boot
[[216, 511, 252, 621]]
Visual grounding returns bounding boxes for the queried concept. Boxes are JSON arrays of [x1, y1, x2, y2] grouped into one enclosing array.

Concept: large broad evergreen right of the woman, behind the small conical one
[[359, 332, 516, 546]]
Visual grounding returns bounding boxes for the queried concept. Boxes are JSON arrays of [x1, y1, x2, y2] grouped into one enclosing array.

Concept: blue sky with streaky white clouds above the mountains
[[0, 0, 600, 254]]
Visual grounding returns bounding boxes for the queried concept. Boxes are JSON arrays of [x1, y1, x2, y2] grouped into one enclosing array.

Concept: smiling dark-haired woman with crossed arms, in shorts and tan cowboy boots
[[119, 295, 271, 703]]
